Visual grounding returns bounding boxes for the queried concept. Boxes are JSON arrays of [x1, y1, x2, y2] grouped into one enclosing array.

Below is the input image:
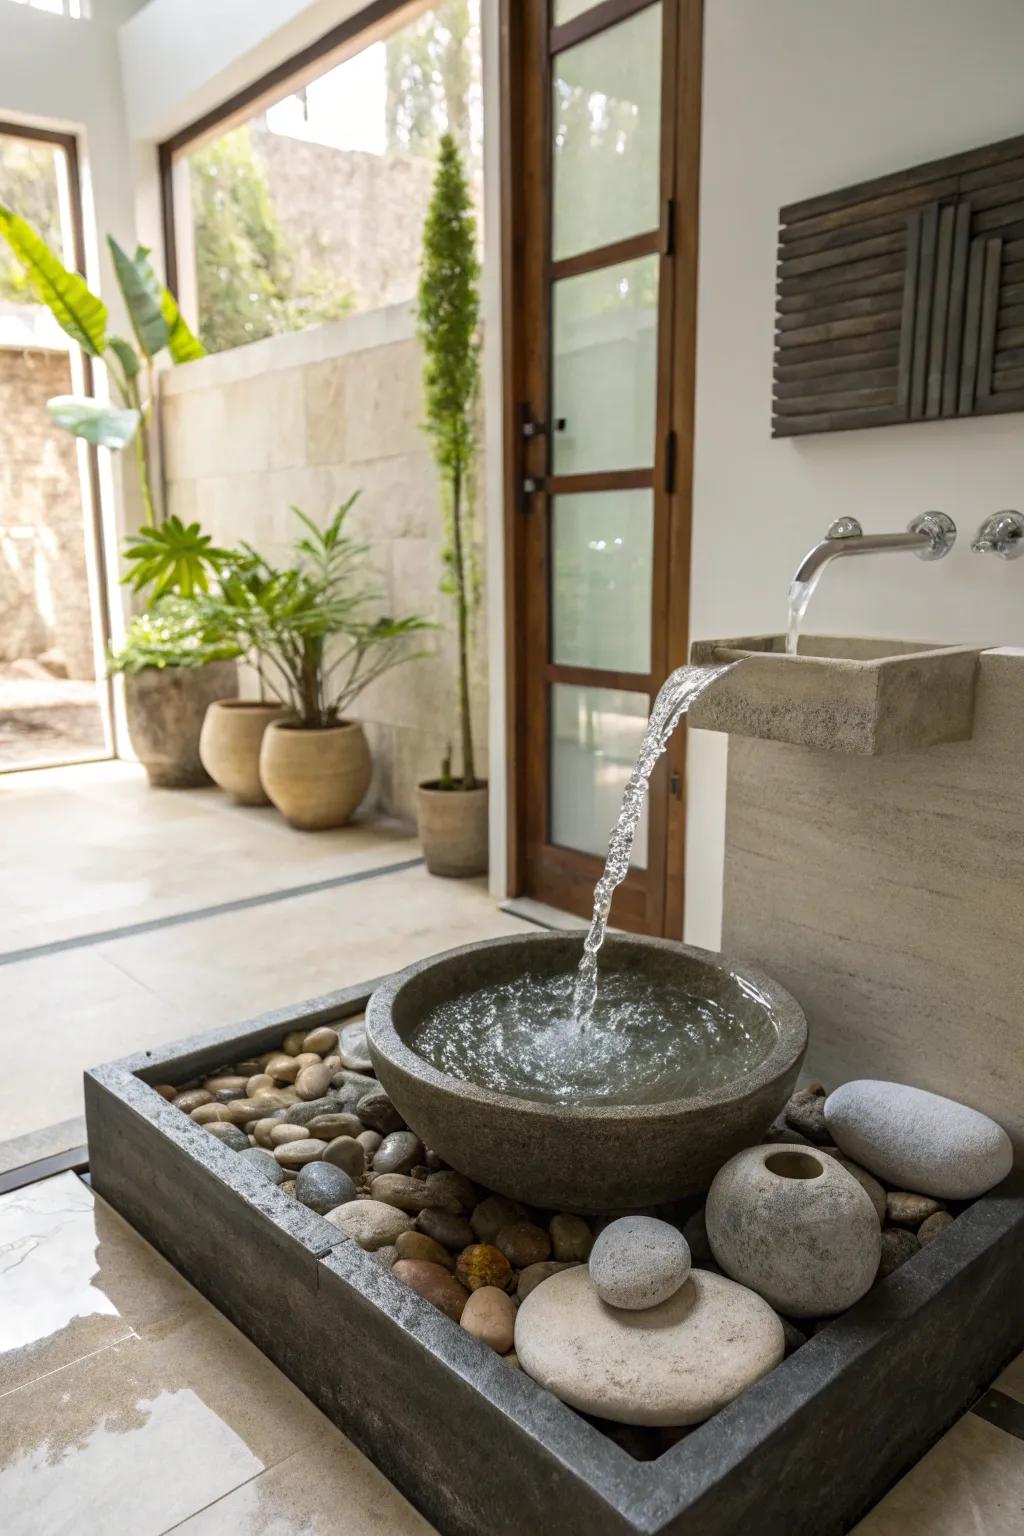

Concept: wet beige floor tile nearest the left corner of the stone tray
[[0, 1174, 197, 1398]]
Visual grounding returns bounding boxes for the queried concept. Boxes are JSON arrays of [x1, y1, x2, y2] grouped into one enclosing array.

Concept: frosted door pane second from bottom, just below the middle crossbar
[[551, 490, 654, 673]]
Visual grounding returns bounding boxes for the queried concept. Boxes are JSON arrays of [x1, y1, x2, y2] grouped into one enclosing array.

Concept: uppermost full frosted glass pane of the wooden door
[[551, 5, 662, 261]]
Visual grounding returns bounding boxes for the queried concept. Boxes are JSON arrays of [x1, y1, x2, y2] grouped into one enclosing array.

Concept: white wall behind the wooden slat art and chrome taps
[[686, 0, 1024, 946]]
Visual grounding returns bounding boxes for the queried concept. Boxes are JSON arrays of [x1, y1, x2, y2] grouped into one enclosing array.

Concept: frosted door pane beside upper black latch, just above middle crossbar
[[551, 257, 657, 475]]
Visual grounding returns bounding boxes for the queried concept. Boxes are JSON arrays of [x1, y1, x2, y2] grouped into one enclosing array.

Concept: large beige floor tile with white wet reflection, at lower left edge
[[0, 1299, 334, 1536]]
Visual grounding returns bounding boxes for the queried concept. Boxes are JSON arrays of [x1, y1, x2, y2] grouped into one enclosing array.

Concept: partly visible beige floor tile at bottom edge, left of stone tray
[[168, 1425, 433, 1536]]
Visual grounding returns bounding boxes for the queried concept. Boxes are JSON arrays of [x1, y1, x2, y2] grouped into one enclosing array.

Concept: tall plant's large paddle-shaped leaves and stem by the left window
[[0, 203, 206, 528]]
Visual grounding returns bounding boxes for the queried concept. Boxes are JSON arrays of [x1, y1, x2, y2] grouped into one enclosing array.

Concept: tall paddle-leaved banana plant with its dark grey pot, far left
[[0, 204, 238, 788]]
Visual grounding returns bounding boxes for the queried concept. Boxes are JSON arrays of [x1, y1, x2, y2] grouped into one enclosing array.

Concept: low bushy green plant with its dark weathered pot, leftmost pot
[[107, 596, 238, 790]]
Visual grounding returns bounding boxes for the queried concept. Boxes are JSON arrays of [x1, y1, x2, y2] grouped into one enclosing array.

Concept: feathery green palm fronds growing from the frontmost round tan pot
[[200, 496, 431, 730]]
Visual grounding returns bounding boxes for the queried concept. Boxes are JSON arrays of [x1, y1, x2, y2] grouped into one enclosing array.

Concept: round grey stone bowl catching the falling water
[[367, 934, 808, 1213]]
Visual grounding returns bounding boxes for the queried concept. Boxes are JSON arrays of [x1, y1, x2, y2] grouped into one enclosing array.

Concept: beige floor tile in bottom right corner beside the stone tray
[[854, 1413, 1024, 1536]]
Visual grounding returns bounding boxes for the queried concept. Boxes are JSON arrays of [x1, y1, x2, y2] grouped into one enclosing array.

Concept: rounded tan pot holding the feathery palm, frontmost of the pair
[[259, 720, 370, 833]]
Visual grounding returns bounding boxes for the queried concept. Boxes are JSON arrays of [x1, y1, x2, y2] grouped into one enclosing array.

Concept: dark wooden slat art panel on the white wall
[[772, 135, 1024, 438]]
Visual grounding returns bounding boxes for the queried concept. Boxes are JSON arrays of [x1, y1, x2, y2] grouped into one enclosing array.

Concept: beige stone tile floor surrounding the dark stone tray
[[0, 763, 1024, 1536]]
